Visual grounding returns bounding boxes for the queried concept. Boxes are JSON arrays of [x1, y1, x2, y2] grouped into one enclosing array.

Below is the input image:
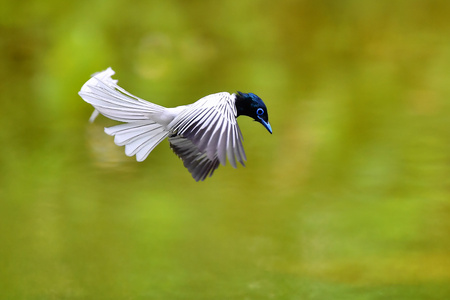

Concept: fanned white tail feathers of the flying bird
[[78, 68, 169, 161]]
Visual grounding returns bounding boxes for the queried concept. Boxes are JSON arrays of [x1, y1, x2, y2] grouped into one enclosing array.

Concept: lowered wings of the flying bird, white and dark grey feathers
[[169, 92, 247, 178]]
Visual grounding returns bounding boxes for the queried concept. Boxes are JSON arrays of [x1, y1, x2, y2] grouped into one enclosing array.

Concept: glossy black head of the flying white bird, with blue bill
[[235, 92, 272, 133]]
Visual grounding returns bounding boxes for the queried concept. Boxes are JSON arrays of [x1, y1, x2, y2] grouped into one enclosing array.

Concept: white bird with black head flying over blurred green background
[[78, 67, 272, 181]]
